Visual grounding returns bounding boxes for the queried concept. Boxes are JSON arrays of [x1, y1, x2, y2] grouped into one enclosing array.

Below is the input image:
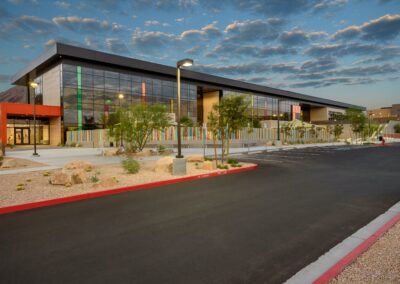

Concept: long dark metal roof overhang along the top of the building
[[12, 43, 365, 110]]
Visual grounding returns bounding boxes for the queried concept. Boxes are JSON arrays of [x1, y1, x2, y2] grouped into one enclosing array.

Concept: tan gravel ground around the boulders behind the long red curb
[[0, 161, 253, 207]]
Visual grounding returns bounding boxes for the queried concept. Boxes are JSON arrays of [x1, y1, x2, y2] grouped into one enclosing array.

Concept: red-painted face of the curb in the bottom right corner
[[313, 213, 400, 284]]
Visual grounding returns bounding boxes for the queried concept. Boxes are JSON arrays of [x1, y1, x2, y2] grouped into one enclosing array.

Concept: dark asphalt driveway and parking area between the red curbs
[[0, 145, 400, 283]]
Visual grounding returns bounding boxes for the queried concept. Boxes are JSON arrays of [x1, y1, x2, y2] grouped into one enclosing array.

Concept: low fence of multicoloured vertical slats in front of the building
[[66, 127, 334, 147]]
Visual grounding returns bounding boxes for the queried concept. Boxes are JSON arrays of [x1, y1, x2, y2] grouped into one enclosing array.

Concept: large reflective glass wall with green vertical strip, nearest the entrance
[[62, 64, 197, 129]]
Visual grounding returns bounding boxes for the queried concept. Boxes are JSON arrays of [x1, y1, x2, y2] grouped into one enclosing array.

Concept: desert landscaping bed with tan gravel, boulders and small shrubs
[[0, 153, 252, 207]]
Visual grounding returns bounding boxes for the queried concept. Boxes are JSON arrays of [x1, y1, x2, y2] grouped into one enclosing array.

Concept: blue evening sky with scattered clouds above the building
[[0, 0, 400, 108]]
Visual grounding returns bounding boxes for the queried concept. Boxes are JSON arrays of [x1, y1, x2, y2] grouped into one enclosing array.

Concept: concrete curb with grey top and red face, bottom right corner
[[285, 202, 400, 284]]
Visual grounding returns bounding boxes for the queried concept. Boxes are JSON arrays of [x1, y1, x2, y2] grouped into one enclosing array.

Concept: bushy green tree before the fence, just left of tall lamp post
[[119, 104, 170, 151]]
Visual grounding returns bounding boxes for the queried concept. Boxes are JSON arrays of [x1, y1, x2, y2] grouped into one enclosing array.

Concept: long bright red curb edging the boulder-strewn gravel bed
[[0, 164, 257, 215]]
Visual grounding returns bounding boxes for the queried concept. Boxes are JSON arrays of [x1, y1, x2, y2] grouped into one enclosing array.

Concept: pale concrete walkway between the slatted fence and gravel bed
[[0, 142, 345, 175]]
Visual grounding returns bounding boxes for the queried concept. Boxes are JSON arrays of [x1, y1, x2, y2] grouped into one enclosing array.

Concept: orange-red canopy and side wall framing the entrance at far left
[[0, 103, 62, 144]]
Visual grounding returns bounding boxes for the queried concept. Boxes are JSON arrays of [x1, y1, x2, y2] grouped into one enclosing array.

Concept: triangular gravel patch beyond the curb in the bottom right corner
[[329, 222, 400, 284]]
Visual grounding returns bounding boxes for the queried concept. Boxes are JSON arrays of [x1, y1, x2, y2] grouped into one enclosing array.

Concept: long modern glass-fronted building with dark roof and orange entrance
[[0, 43, 364, 145]]
